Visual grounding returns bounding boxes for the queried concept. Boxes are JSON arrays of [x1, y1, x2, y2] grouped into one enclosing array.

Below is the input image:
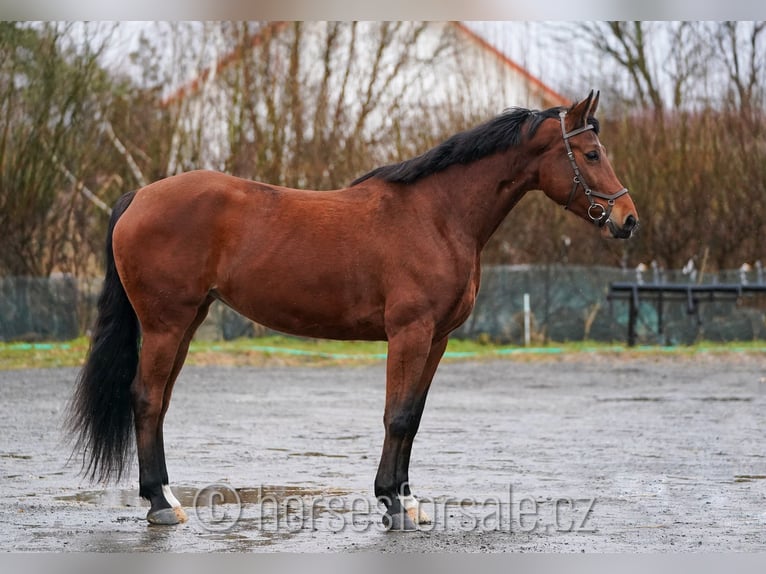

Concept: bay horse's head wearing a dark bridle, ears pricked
[[540, 91, 638, 239]]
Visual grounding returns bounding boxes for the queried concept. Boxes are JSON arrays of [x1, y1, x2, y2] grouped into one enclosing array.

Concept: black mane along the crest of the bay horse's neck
[[351, 107, 598, 186]]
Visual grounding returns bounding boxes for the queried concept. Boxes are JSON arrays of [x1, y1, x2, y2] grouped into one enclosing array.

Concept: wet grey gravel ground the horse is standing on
[[0, 356, 766, 552]]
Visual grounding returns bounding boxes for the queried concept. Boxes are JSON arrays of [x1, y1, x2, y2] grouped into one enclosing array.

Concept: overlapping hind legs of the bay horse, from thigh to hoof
[[131, 306, 208, 524]]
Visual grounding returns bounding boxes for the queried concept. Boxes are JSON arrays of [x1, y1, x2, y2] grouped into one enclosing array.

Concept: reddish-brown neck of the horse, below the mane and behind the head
[[431, 151, 536, 250]]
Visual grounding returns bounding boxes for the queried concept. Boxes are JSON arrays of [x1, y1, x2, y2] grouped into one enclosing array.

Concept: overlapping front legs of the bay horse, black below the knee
[[375, 322, 447, 530]]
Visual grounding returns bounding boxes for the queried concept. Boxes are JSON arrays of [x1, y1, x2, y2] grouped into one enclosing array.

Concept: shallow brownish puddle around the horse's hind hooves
[[55, 483, 351, 507]]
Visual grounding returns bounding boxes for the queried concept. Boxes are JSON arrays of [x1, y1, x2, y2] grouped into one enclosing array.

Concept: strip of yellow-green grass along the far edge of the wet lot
[[0, 336, 766, 369]]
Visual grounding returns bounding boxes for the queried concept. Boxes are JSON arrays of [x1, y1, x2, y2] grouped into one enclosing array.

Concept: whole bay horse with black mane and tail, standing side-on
[[68, 91, 638, 530]]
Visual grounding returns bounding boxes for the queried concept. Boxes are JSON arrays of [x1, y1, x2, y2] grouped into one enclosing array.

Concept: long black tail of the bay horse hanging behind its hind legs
[[68, 192, 140, 481]]
